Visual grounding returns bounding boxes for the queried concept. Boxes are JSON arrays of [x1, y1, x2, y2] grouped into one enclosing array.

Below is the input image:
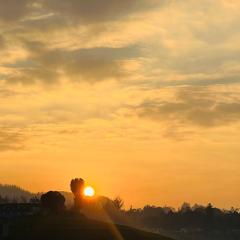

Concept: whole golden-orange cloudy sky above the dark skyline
[[0, 0, 240, 208]]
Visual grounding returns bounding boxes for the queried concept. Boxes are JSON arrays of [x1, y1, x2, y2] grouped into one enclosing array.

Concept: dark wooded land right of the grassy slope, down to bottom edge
[[122, 203, 240, 240]]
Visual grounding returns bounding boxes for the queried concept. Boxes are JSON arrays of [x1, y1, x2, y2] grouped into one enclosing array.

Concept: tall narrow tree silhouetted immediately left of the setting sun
[[70, 178, 84, 210]]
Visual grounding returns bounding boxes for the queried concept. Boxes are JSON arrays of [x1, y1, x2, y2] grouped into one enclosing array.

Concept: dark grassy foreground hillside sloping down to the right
[[3, 215, 170, 240]]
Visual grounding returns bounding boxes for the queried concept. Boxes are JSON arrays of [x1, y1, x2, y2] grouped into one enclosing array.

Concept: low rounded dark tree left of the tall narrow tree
[[41, 191, 65, 213]]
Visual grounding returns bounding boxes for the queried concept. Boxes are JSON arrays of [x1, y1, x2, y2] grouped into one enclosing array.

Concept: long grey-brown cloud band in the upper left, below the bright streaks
[[6, 41, 139, 84]]
